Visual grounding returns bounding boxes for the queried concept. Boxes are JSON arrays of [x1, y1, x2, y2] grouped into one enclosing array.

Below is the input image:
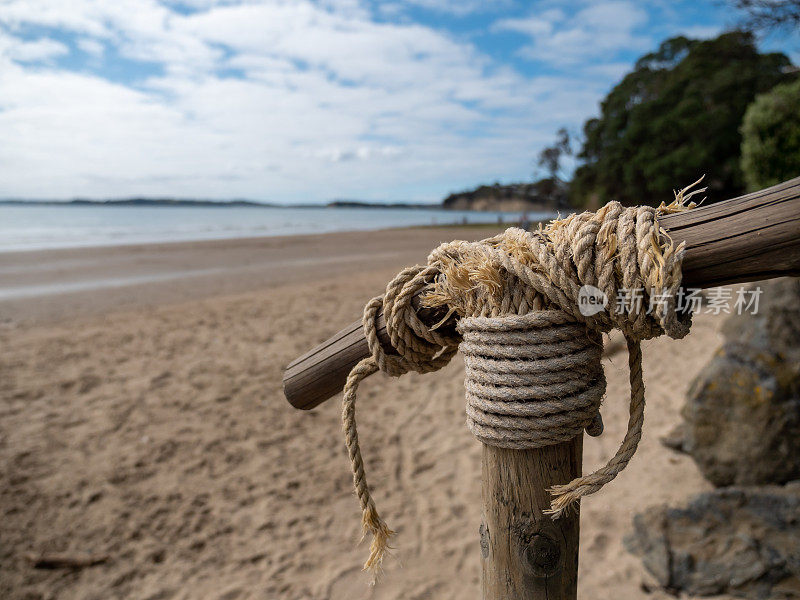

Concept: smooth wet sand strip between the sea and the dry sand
[[0, 224, 503, 326]]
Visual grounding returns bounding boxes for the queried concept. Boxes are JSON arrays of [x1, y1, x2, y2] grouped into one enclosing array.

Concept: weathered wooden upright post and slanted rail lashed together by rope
[[283, 177, 800, 600]]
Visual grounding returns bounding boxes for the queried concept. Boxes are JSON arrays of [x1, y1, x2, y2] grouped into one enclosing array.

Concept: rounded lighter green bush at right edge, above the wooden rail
[[741, 78, 800, 190]]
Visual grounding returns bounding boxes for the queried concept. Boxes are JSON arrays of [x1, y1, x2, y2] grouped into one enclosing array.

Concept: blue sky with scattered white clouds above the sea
[[0, 0, 800, 203]]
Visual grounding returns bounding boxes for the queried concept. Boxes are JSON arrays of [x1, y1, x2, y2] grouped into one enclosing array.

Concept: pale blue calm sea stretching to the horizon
[[0, 204, 553, 252]]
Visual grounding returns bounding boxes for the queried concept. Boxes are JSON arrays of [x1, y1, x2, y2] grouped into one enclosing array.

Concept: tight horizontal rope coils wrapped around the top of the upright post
[[458, 310, 606, 450]]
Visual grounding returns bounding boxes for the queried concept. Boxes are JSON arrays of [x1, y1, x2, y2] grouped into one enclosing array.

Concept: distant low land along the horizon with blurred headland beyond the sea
[[0, 179, 567, 212]]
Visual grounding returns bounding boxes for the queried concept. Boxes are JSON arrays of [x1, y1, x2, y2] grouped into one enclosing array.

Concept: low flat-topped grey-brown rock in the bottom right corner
[[625, 482, 800, 600]]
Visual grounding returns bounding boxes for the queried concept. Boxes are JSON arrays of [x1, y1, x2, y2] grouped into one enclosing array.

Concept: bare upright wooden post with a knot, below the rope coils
[[480, 435, 583, 600]]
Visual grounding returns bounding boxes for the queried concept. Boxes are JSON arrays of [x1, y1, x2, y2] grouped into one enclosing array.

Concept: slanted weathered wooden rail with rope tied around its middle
[[283, 177, 800, 409]]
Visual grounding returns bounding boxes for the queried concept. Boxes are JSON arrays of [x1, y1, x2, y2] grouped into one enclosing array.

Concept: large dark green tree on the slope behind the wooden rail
[[571, 31, 791, 205]]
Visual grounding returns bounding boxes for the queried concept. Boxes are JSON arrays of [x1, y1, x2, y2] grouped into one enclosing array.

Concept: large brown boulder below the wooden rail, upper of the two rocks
[[680, 279, 800, 486]]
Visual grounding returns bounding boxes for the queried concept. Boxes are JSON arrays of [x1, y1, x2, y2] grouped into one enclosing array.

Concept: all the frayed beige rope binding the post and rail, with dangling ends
[[342, 184, 703, 576]]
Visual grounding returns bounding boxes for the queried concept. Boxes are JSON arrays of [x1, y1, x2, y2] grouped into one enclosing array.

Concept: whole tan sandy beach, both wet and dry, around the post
[[0, 228, 722, 600]]
